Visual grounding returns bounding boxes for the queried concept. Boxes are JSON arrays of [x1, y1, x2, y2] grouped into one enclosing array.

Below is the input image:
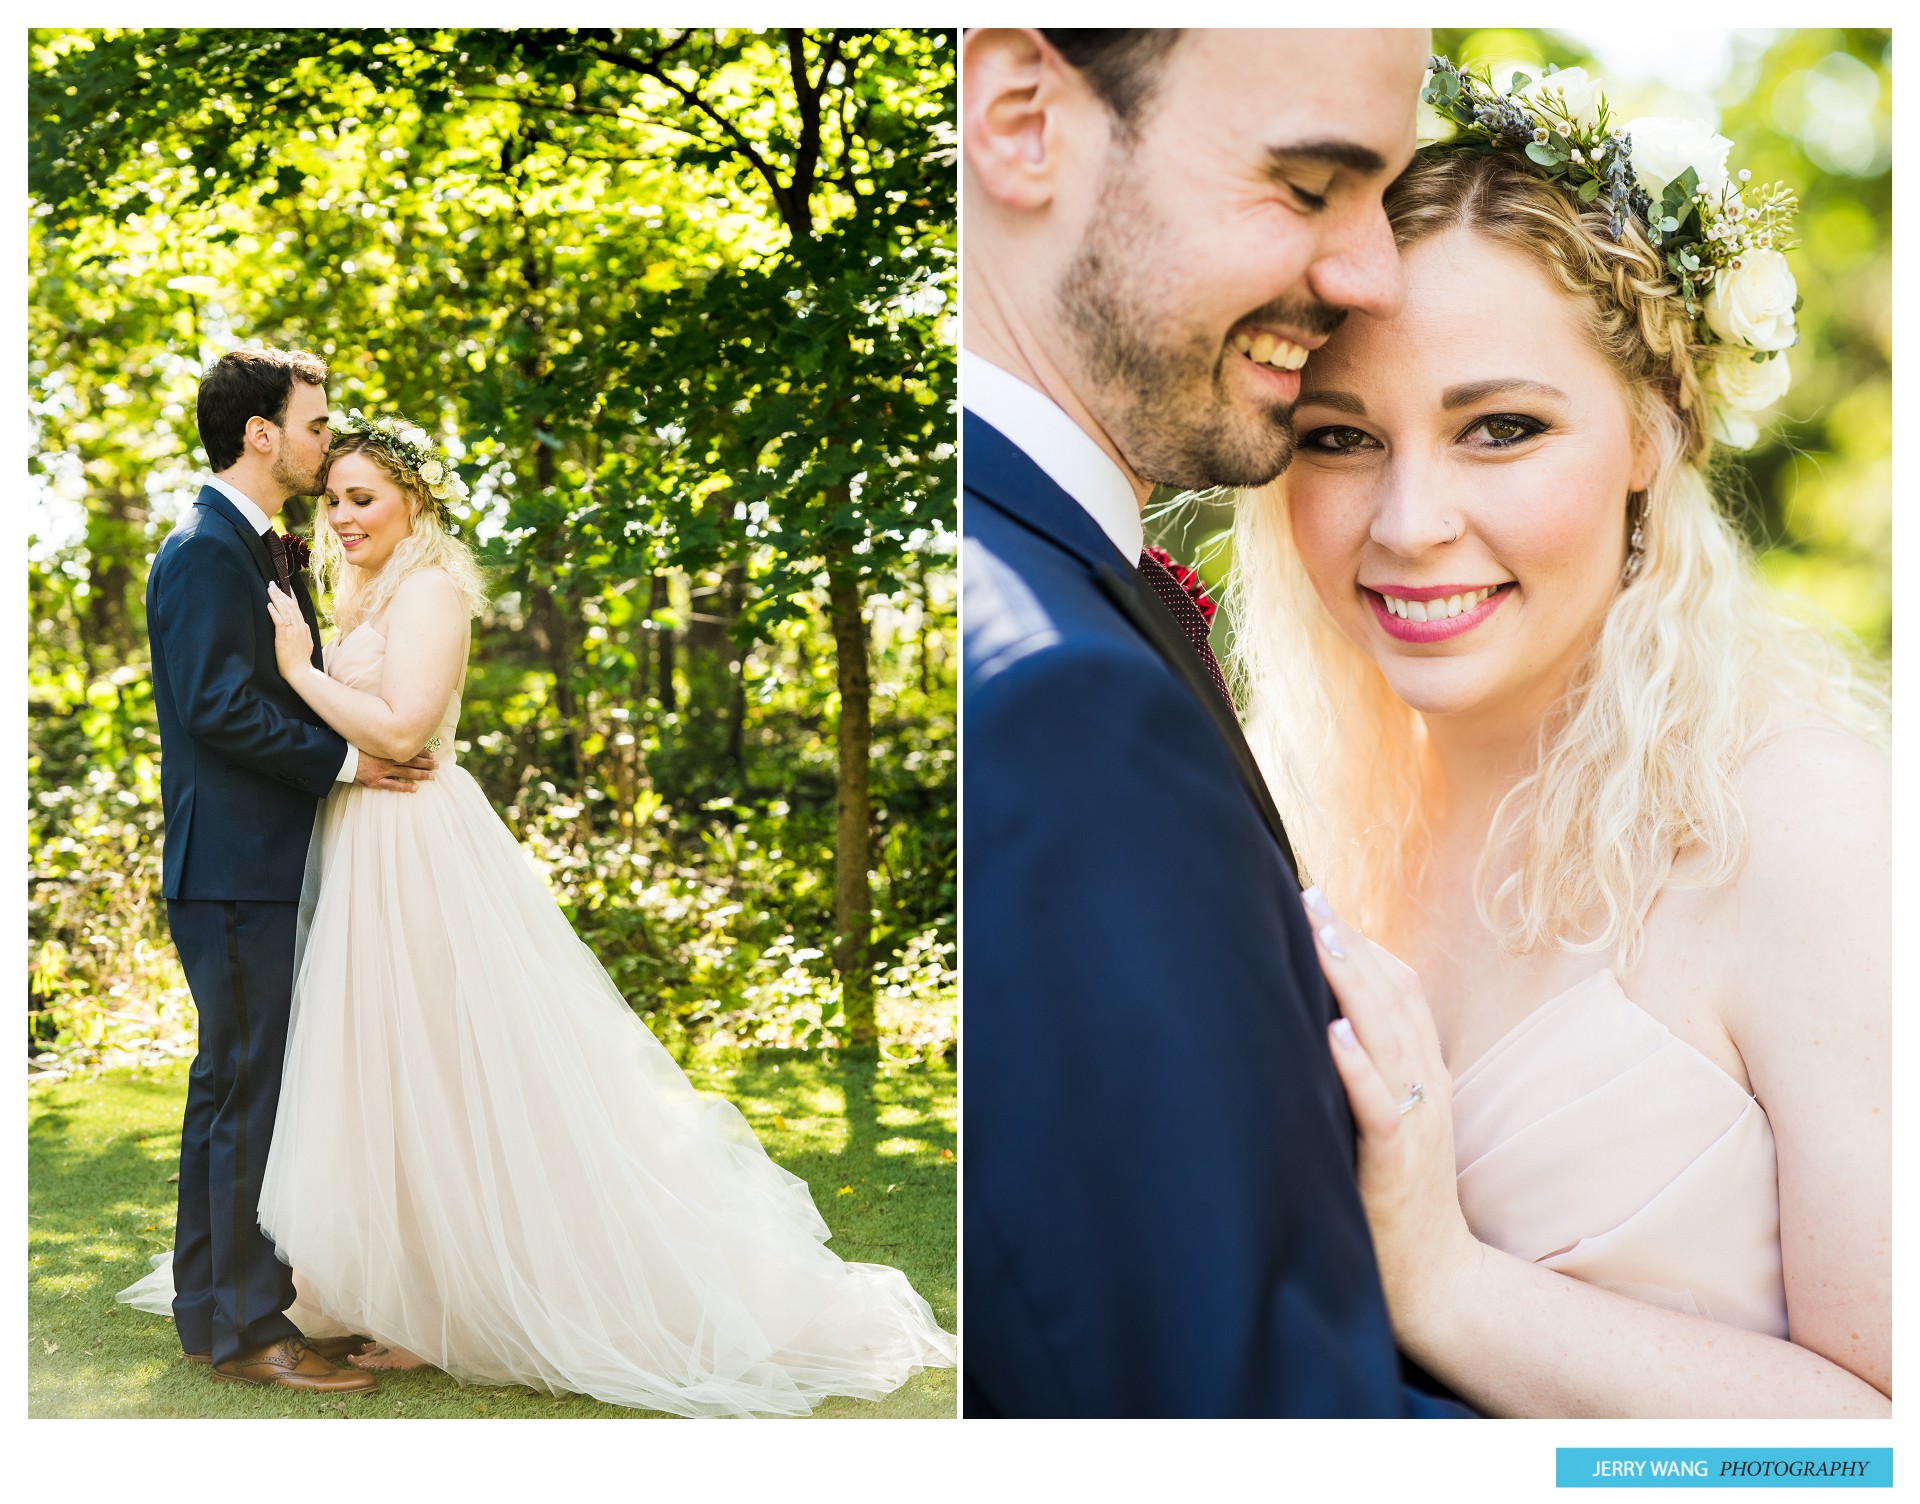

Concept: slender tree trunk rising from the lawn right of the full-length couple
[[828, 544, 876, 1045]]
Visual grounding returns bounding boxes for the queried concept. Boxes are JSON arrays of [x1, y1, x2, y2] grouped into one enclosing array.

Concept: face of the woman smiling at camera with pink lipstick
[[1286, 230, 1651, 715]]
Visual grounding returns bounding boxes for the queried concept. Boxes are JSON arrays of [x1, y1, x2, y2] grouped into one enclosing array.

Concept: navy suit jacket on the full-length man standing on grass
[[146, 486, 348, 903]]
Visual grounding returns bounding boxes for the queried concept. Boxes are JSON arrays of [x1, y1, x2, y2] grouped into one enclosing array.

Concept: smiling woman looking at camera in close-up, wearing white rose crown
[[1235, 73, 1893, 1416]]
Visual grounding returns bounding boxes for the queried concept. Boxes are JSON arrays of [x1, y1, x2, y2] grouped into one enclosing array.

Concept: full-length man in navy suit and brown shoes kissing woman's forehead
[[146, 350, 434, 1391]]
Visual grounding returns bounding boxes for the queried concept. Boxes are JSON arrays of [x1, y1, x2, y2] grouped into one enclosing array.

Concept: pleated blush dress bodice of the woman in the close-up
[[1453, 970, 1788, 1337]]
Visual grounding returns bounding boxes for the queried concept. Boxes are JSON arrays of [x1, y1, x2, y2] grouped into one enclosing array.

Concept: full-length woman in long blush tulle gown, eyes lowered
[[161, 417, 954, 1416]]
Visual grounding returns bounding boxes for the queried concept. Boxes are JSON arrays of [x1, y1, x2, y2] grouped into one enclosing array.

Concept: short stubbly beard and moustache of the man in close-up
[[1054, 158, 1346, 490]]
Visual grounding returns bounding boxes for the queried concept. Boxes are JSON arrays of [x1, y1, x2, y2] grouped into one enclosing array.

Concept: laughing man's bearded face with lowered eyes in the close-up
[[1056, 31, 1427, 490]]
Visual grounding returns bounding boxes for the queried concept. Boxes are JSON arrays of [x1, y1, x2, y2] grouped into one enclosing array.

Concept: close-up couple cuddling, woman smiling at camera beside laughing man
[[962, 29, 1891, 1416]]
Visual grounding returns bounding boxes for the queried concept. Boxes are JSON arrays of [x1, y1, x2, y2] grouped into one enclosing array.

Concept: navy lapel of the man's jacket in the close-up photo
[[964, 413, 1300, 882]]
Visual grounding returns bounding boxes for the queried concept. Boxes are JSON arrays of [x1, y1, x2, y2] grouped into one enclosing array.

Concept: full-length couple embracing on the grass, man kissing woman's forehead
[[121, 350, 954, 1416]]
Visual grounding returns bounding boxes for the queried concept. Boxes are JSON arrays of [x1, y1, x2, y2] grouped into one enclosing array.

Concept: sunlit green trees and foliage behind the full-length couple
[[29, 29, 956, 1075]]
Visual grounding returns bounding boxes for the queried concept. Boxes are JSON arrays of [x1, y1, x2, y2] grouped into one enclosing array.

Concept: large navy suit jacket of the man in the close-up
[[962, 415, 1459, 1416]]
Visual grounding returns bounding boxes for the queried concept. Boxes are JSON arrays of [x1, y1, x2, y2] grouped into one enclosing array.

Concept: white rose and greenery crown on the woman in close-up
[[1421, 58, 1801, 448]]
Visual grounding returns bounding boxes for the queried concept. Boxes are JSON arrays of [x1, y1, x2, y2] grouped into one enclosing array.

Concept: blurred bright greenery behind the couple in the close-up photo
[[1150, 27, 1893, 672]]
